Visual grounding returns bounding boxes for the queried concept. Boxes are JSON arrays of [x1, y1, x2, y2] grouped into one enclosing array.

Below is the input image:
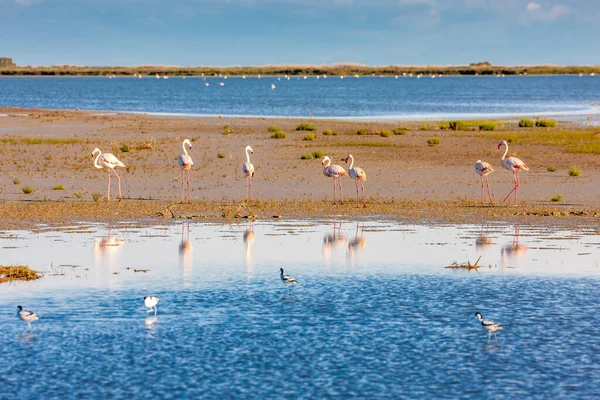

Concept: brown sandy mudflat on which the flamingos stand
[[0, 108, 600, 228]]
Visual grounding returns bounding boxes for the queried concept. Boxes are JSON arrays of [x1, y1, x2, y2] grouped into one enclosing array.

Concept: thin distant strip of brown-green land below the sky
[[0, 63, 600, 77]]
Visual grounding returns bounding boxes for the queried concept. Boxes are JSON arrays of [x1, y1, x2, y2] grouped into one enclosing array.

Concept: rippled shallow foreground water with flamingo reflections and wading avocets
[[0, 221, 600, 399]]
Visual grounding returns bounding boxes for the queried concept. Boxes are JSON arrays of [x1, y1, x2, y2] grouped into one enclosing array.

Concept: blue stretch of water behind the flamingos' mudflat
[[0, 76, 600, 120]]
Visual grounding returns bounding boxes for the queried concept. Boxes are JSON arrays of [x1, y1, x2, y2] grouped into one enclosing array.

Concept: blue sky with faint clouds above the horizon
[[0, 0, 600, 66]]
